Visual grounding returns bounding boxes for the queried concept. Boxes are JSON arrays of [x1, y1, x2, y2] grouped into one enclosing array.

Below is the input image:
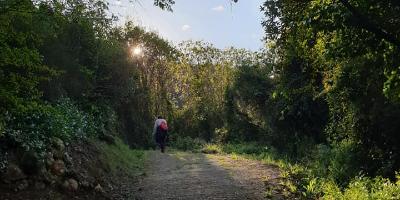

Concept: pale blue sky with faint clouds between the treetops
[[108, 0, 264, 50]]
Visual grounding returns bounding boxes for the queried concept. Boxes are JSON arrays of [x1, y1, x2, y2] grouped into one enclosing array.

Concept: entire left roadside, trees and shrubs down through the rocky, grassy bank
[[0, 0, 174, 195]]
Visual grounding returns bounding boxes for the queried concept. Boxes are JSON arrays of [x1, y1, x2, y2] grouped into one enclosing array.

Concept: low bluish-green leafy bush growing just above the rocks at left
[[0, 98, 115, 154]]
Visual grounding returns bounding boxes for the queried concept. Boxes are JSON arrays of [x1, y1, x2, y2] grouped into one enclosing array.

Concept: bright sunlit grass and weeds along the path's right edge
[[203, 143, 400, 200]]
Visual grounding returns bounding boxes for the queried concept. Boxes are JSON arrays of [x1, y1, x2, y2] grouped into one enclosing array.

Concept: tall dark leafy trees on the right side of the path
[[263, 0, 400, 176]]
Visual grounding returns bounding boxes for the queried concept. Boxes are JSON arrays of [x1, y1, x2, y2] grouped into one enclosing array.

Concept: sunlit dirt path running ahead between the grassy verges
[[136, 151, 282, 200]]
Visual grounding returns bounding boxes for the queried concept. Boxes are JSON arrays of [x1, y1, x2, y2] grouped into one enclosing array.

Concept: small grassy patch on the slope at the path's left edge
[[97, 139, 146, 175]]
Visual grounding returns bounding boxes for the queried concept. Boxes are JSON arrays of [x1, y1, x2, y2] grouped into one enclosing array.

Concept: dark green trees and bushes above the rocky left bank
[[0, 0, 174, 162]]
